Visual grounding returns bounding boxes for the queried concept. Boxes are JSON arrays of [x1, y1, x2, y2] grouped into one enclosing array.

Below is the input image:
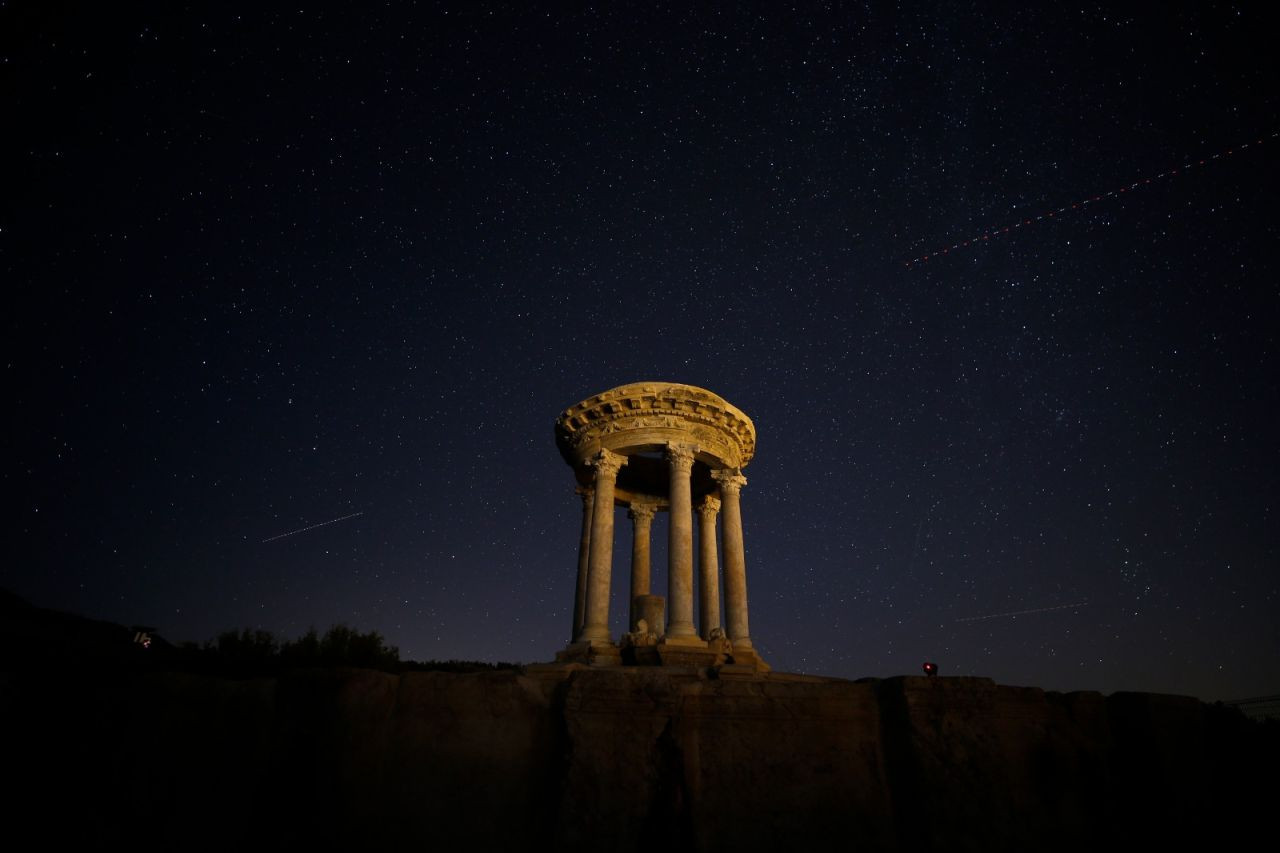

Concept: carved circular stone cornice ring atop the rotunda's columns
[[556, 382, 755, 467]]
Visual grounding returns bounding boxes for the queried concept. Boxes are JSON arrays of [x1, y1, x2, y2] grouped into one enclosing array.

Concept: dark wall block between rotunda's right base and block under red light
[[673, 679, 892, 850]]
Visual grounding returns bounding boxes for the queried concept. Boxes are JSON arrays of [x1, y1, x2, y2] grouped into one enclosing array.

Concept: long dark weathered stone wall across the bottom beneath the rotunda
[[0, 666, 1280, 850]]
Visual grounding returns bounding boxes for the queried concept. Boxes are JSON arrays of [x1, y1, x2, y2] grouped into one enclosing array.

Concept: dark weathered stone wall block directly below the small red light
[[878, 678, 1111, 849]]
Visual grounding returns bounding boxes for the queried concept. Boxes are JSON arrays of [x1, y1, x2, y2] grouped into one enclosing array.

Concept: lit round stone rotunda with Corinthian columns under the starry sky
[[556, 382, 768, 670]]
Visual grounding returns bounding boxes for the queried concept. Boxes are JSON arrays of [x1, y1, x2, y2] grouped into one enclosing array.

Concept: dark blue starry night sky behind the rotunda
[[0, 0, 1280, 699]]
